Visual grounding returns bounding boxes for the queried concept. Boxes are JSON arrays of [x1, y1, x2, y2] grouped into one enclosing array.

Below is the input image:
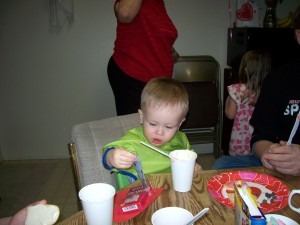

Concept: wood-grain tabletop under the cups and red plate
[[59, 167, 300, 225]]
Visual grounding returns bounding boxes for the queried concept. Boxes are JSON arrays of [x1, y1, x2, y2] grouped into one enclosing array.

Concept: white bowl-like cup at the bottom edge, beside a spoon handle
[[151, 207, 193, 225]]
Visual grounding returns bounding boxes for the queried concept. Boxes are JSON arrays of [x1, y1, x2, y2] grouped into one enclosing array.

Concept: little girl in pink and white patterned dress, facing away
[[225, 50, 271, 156]]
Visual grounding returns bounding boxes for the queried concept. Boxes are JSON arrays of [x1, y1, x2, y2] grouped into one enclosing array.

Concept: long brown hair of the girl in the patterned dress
[[239, 50, 272, 105]]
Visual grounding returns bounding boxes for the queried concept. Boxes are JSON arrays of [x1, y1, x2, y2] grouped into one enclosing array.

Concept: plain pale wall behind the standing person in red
[[0, 0, 298, 160]]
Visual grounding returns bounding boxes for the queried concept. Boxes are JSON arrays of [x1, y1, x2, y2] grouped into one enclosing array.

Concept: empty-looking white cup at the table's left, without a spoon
[[78, 183, 116, 225]]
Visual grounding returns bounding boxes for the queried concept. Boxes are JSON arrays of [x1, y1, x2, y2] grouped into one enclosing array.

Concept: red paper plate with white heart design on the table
[[207, 171, 290, 213]]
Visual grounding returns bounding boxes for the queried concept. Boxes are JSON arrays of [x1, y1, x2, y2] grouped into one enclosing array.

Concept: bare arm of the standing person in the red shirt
[[115, 0, 143, 23]]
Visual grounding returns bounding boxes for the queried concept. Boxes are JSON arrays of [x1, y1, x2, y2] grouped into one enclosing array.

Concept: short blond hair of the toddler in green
[[141, 77, 189, 118]]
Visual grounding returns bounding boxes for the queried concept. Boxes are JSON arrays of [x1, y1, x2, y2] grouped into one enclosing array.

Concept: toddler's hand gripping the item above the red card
[[106, 147, 136, 169]]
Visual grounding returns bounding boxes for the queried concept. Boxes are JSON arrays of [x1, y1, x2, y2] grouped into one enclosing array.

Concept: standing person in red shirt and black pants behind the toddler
[[107, 0, 178, 115]]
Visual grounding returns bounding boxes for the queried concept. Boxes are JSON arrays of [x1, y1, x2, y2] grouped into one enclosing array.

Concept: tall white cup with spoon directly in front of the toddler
[[170, 150, 197, 192]]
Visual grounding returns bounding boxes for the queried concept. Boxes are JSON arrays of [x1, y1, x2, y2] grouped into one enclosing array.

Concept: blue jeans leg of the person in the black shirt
[[212, 155, 262, 170]]
